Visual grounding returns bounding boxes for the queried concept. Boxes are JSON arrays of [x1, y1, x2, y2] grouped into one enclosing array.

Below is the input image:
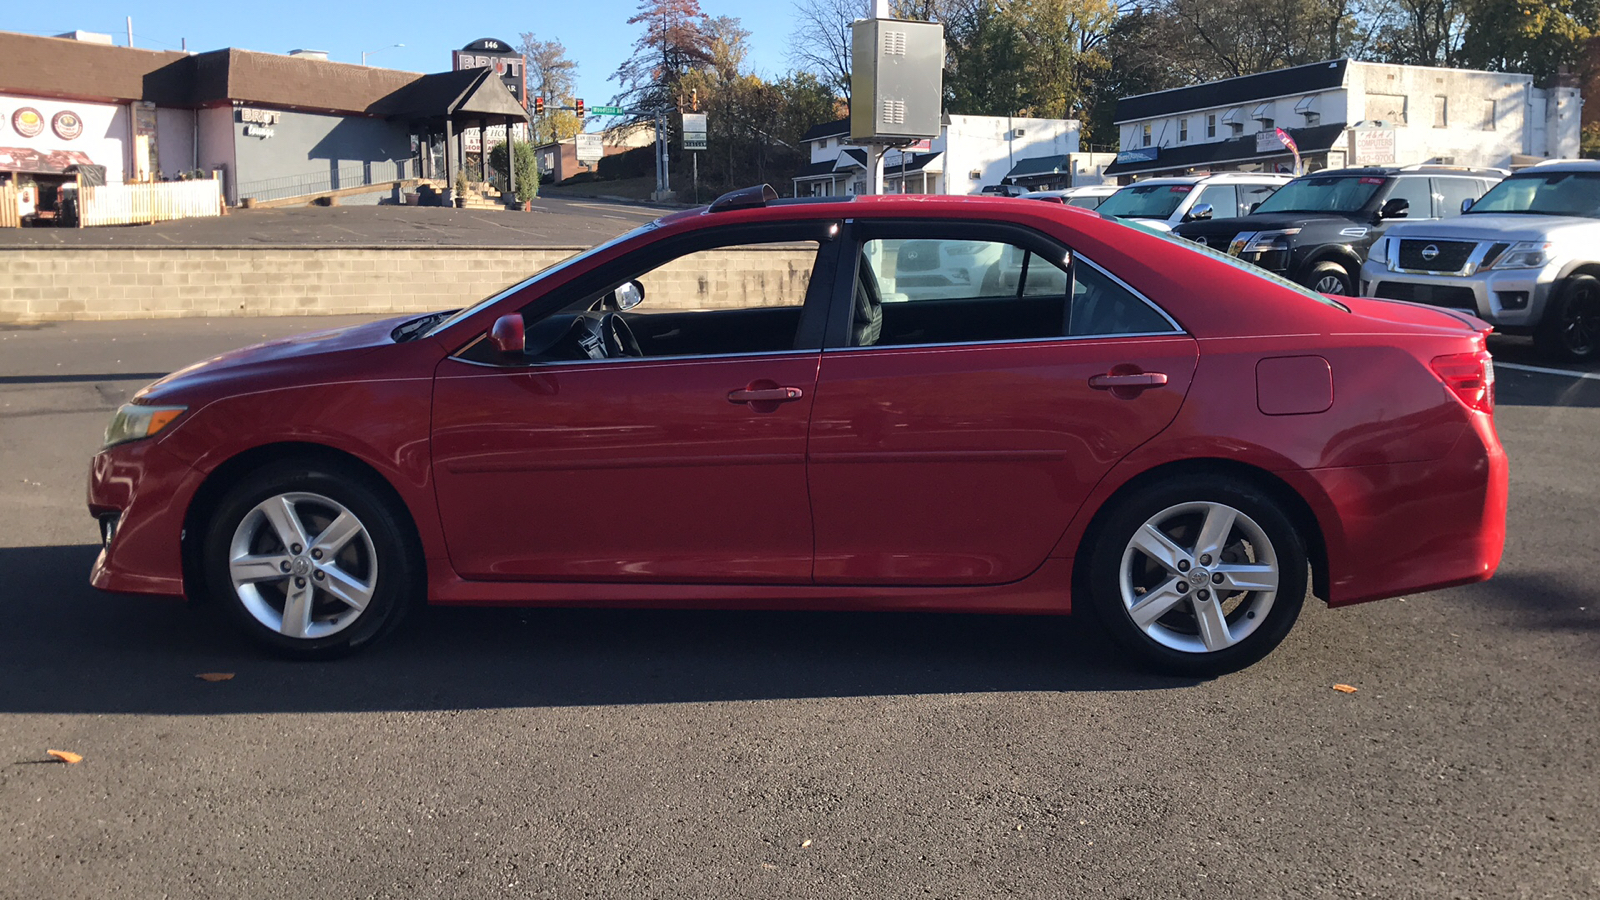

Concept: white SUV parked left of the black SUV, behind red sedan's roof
[[1096, 171, 1293, 231]]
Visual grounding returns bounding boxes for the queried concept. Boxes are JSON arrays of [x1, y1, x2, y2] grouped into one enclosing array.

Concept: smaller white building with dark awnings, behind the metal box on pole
[[794, 115, 1110, 197]]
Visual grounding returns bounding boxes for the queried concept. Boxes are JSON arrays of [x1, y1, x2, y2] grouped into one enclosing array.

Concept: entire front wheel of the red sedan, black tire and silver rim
[[202, 460, 426, 658]]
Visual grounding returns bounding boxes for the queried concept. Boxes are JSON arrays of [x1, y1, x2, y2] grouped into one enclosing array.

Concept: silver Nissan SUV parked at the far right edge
[[1362, 160, 1600, 360]]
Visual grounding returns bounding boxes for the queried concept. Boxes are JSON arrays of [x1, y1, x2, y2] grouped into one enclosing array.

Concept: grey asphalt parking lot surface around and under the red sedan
[[0, 319, 1600, 898]]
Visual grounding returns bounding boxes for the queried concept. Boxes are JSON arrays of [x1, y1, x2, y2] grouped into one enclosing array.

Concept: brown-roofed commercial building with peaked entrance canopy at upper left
[[0, 32, 526, 203]]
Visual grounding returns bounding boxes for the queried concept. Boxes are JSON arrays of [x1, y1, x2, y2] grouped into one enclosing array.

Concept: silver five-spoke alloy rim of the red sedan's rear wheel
[[1118, 501, 1280, 653]]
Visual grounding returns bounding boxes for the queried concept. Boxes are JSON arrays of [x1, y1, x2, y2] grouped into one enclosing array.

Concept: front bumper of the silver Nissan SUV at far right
[[1362, 259, 1560, 330]]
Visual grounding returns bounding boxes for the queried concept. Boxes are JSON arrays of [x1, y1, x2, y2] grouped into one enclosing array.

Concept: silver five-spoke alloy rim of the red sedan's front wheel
[[227, 492, 378, 641]]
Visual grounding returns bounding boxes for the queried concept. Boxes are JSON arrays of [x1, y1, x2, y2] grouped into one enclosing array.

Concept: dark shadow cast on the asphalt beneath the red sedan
[[0, 546, 1197, 716]]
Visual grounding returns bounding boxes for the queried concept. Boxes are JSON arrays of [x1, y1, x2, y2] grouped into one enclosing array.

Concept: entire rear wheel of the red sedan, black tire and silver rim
[[1088, 476, 1307, 676]]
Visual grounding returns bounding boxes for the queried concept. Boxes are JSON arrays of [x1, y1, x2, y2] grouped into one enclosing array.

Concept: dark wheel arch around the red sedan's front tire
[[179, 440, 427, 602]]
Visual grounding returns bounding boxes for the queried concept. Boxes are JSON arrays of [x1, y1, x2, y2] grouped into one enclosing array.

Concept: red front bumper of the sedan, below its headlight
[[88, 440, 205, 596]]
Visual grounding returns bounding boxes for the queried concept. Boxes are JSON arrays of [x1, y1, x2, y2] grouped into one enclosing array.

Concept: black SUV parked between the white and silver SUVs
[[1173, 165, 1506, 296]]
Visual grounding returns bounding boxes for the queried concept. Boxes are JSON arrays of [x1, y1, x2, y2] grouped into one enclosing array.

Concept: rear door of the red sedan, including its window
[[808, 223, 1197, 585]]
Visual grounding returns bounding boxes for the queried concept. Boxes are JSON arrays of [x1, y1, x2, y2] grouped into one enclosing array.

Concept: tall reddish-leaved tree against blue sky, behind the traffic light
[[611, 0, 712, 120]]
